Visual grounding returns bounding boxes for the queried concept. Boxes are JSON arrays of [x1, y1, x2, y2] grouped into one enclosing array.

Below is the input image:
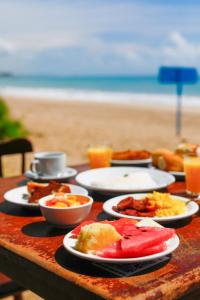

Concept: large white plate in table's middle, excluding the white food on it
[[76, 167, 175, 194]]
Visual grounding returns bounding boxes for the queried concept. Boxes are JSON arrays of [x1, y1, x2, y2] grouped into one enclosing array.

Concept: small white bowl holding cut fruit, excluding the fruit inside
[[38, 194, 93, 226]]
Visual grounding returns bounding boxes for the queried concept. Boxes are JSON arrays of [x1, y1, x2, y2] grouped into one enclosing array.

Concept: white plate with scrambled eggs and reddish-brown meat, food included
[[103, 191, 199, 222]]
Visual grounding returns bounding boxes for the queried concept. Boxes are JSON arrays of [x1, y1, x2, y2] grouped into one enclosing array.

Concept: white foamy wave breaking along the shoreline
[[0, 86, 200, 107]]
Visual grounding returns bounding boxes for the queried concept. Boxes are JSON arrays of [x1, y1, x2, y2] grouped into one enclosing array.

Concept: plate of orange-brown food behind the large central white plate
[[111, 150, 152, 166]]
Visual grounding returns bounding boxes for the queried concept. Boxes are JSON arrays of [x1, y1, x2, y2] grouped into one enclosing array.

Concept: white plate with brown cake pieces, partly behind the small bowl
[[4, 181, 88, 208]]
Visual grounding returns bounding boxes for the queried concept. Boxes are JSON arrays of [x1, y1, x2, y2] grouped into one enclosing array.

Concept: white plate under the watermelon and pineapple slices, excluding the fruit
[[63, 232, 179, 263]]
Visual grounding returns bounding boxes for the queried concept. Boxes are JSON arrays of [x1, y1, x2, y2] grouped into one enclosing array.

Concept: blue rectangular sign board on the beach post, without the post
[[159, 67, 198, 84]]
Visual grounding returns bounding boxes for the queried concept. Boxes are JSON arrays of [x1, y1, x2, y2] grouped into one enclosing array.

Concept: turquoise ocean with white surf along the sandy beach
[[0, 75, 200, 106]]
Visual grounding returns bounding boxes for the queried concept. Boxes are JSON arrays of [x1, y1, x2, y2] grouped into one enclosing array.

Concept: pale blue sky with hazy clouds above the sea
[[0, 0, 200, 76]]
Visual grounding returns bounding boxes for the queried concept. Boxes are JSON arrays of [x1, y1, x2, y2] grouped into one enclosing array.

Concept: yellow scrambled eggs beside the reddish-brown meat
[[148, 192, 186, 217]]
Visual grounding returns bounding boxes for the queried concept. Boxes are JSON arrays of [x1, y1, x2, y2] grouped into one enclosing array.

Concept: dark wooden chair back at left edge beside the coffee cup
[[0, 139, 33, 177]]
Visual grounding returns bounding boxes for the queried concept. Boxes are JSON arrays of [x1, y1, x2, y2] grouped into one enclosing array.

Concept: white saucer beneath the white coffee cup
[[24, 167, 77, 182]]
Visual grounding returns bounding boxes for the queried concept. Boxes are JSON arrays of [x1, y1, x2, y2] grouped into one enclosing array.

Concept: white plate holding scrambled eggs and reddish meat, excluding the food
[[103, 194, 199, 222]]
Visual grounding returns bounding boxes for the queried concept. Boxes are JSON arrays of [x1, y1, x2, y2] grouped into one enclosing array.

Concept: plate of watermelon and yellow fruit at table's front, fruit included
[[63, 218, 179, 263]]
